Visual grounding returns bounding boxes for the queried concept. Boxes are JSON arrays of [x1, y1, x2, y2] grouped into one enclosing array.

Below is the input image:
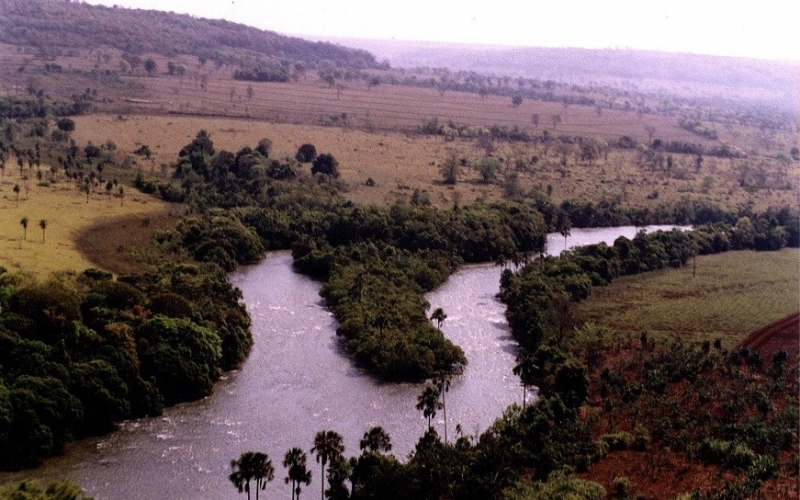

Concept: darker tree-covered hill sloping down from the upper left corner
[[0, 0, 378, 69]]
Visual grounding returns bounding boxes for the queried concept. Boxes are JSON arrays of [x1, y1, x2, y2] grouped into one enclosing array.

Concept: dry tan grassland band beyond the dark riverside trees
[[74, 115, 800, 209]]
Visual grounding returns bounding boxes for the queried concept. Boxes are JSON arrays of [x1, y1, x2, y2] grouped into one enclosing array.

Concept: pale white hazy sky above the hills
[[86, 0, 800, 61]]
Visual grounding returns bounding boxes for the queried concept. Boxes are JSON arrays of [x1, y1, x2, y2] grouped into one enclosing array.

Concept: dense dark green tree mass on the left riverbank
[[0, 264, 252, 470]]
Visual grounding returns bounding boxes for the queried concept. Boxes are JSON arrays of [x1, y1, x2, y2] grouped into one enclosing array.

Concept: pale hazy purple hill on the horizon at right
[[328, 38, 800, 113]]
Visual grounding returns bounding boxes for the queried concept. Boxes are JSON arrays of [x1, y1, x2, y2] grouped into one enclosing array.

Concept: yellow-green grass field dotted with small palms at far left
[[0, 168, 176, 276]]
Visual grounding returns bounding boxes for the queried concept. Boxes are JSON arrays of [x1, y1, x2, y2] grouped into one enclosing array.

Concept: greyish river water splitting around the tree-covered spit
[[0, 226, 680, 500]]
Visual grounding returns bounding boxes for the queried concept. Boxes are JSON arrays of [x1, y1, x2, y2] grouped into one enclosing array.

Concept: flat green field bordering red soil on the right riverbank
[[578, 249, 800, 347]]
